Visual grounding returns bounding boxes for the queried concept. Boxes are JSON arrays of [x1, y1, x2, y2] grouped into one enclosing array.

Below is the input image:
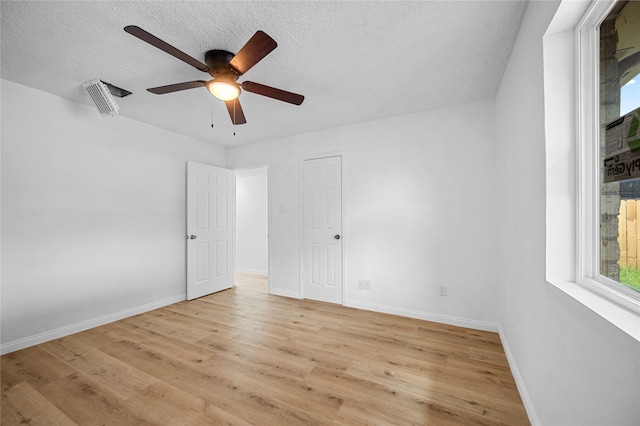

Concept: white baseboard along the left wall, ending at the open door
[[0, 293, 187, 355]]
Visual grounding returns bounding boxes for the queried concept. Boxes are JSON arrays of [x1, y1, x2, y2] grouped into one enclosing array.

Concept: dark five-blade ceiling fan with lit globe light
[[124, 25, 304, 124]]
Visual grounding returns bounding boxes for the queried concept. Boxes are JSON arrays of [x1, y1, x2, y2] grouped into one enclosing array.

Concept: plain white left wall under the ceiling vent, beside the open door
[[1, 80, 226, 352]]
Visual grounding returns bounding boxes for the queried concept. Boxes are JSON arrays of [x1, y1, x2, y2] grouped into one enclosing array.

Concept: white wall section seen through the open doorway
[[236, 167, 268, 275]]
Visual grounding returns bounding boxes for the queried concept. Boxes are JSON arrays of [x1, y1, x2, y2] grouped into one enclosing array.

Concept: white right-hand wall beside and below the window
[[496, 1, 640, 426]]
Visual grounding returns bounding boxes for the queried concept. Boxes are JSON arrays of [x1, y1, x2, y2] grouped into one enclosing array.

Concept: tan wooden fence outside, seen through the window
[[618, 200, 640, 268]]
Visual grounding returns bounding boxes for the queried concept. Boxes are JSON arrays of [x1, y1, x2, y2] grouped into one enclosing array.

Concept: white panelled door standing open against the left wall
[[187, 161, 233, 300]]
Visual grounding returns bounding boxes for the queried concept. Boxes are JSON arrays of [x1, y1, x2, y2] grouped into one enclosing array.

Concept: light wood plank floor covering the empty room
[[1, 275, 529, 426]]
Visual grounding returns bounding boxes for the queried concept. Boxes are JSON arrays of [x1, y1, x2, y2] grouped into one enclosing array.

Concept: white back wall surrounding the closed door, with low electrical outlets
[[228, 101, 498, 329]]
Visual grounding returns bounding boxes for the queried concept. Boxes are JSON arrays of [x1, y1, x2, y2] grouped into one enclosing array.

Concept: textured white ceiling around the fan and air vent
[[0, 1, 526, 146]]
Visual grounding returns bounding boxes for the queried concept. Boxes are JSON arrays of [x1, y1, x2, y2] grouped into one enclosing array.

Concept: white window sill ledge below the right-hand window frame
[[549, 281, 640, 342]]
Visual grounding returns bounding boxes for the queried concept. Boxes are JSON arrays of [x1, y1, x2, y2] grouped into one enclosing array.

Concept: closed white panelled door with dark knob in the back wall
[[302, 157, 343, 303]]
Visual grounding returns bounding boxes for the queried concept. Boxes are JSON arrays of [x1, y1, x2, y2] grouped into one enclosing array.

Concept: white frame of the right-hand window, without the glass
[[575, 0, 640, 314]]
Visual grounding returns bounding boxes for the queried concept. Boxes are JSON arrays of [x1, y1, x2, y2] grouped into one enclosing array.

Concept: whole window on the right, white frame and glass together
[[577, 1, 640, 311]]
